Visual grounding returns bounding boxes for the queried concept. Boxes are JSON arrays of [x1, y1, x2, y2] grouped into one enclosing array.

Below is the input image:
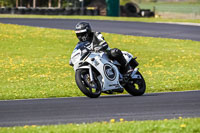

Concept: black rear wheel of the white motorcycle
[[124, 71, 146, 96]]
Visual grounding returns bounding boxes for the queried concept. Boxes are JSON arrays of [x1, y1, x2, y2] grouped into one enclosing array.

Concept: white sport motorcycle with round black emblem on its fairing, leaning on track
[[70, 42, 146, 98]]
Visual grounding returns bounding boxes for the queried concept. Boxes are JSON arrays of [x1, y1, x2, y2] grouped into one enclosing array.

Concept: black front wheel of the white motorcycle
[[75, 69, 101, 98]]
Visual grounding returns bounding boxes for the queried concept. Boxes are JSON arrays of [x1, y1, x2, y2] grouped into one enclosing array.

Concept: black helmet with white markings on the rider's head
[[75, 22, 92, 42]]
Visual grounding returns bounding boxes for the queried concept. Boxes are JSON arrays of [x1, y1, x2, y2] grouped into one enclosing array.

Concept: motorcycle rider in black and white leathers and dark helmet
[[70, 22, 130, 74]]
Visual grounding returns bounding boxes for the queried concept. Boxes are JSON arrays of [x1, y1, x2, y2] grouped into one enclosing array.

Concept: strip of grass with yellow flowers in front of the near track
[[0, 118, 200, 133]]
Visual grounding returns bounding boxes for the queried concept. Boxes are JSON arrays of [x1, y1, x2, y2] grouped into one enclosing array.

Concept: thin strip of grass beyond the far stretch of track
[[0, 14, 200, 23]]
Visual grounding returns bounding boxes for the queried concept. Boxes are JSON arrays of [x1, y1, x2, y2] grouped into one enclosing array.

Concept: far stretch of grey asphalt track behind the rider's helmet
[[0, 18, 200, 41]]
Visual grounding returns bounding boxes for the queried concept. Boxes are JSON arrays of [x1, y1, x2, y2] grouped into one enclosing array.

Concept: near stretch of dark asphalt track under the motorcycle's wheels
[[0, 91, 200, 126]]
